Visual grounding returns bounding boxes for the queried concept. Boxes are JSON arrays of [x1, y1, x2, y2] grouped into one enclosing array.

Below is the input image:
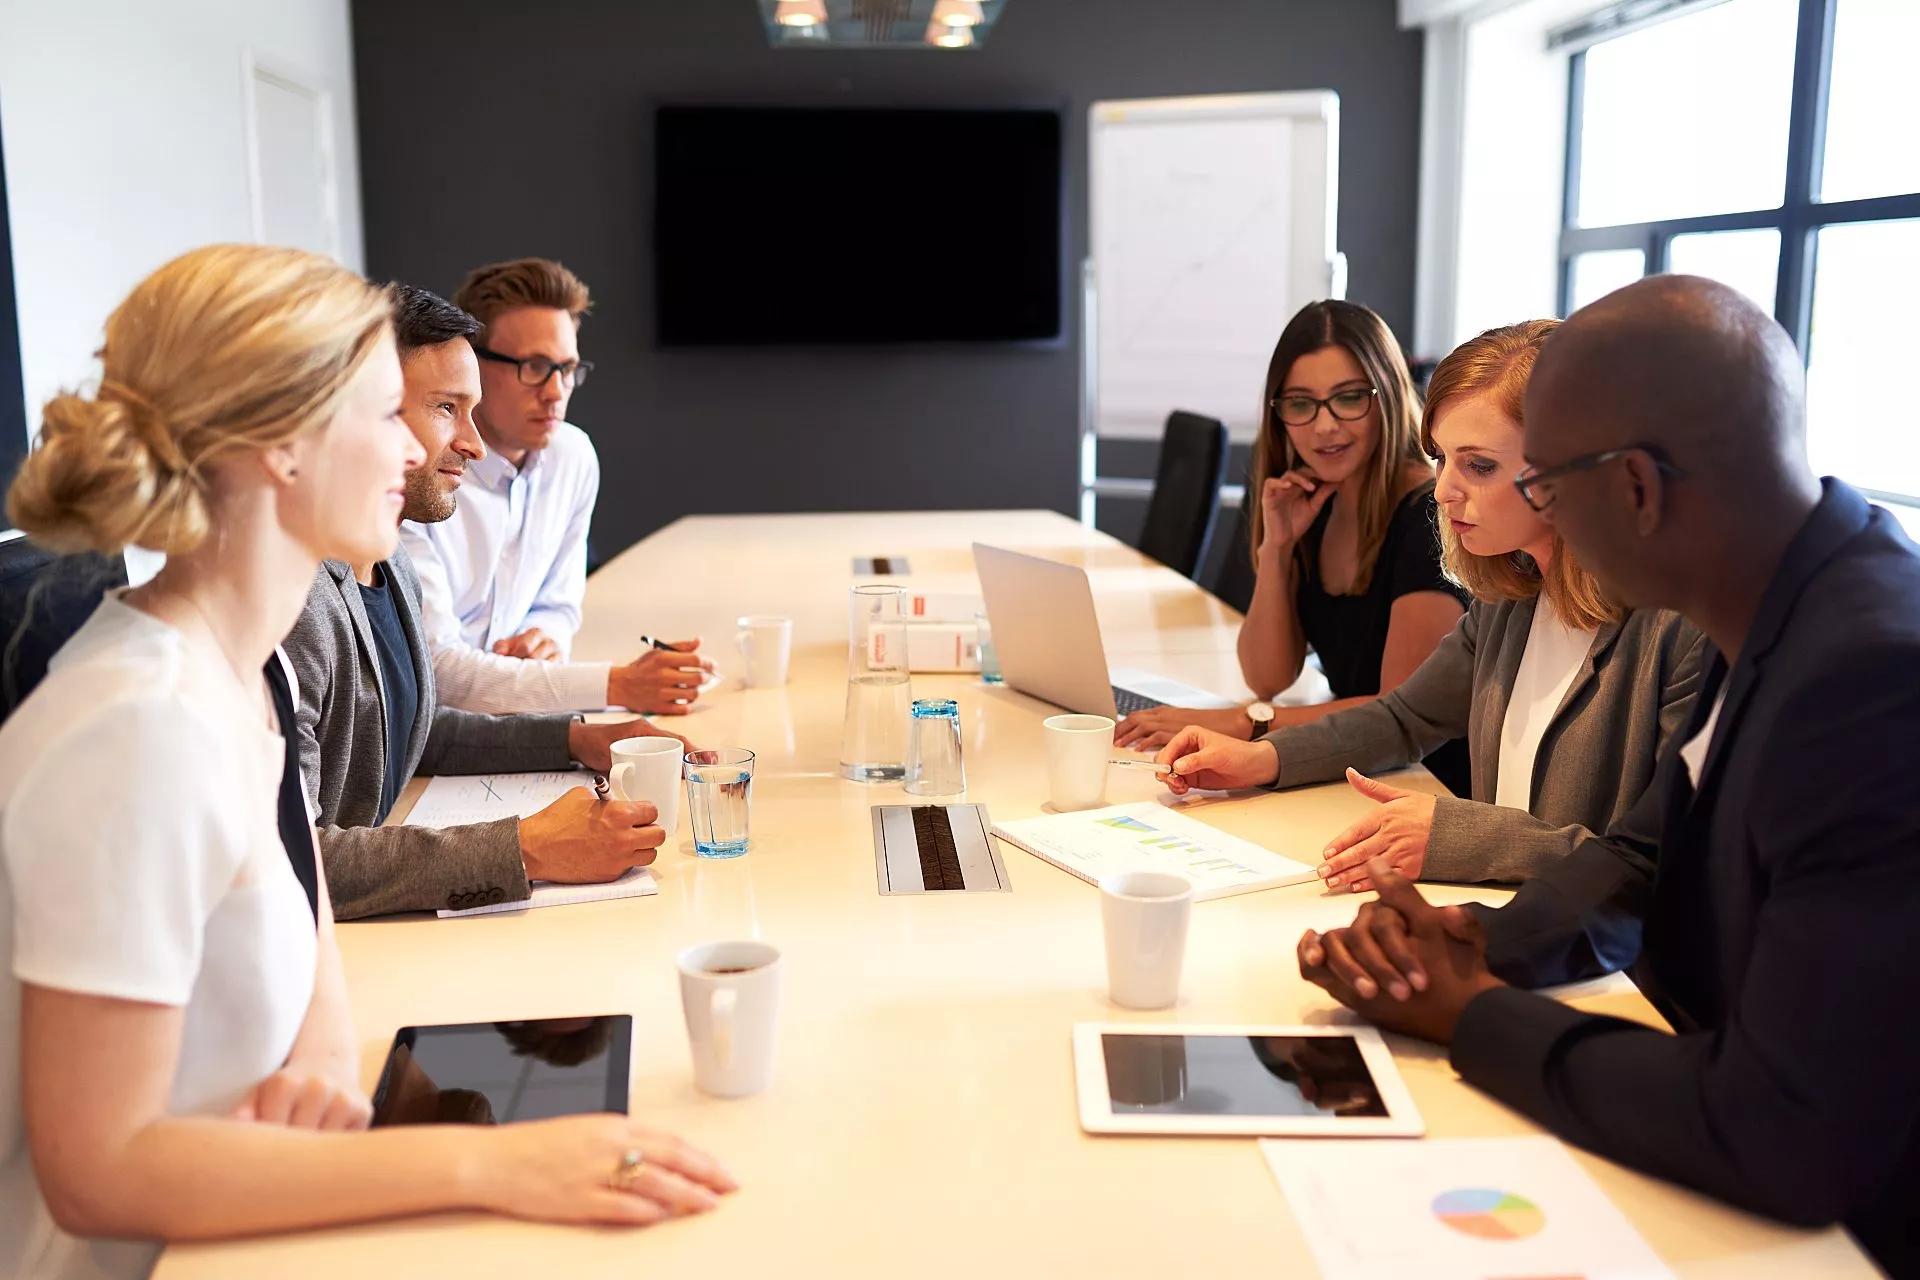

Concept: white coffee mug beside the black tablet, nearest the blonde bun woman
[[676, 942, 780, 1098]]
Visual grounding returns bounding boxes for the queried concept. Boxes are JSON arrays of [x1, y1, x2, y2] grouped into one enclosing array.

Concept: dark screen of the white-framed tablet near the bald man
[[1100, 1032, 1386, 1117]]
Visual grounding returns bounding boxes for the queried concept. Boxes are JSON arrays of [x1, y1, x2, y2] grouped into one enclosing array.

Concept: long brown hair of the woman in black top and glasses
[[1246, 297, 1427, 595]]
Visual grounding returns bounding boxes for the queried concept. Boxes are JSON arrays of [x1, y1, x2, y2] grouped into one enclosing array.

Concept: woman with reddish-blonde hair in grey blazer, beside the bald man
[[1158, 320, 1705, 892]]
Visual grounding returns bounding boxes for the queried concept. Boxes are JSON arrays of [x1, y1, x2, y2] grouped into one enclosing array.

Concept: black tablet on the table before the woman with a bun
[[360, 1013, 634, 1126]]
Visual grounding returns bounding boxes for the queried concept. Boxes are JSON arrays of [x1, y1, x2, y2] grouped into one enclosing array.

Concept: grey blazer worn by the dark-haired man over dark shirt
[[284, 547, 574, 919]]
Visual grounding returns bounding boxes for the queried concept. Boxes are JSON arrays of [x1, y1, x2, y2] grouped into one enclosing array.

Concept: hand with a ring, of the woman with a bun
[[472, 1115, 739, 1226]]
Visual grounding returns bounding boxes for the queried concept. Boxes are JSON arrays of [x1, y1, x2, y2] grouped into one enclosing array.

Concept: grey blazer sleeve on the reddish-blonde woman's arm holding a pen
[[1260, 608, 1478, 789]]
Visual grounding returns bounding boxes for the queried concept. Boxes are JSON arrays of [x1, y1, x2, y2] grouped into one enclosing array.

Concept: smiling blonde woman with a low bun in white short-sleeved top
[[0, 246, 732, 1280]]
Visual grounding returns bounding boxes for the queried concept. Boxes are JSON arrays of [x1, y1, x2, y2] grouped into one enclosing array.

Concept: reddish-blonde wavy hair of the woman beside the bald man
[[1421, 320, 1626, 631]]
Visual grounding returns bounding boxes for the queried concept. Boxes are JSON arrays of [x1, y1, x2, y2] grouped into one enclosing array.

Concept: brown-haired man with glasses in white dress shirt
[[401, 257, 712, 714]]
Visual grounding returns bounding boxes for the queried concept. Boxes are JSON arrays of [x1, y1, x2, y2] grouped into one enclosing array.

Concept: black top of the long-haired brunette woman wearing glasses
[[1294, 482, 1473, 796]]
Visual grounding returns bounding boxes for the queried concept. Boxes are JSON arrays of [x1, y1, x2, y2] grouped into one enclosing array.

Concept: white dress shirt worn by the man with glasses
[[399, 422, 612, 712]]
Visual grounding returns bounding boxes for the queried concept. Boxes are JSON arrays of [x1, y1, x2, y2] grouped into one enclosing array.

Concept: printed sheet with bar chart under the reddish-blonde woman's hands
[[993, 800, 1317, 902]]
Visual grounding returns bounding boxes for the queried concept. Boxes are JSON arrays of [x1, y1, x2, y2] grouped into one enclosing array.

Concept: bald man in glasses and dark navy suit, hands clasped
[[1298, 276, 1920, 1276]]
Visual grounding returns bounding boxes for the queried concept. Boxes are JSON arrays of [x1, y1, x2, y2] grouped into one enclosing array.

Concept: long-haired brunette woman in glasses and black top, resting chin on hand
[[1116, 299, 1467, 791]]
